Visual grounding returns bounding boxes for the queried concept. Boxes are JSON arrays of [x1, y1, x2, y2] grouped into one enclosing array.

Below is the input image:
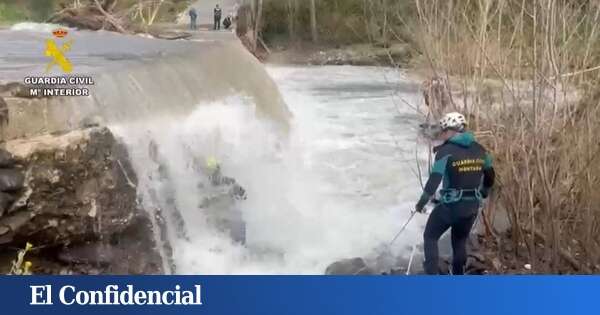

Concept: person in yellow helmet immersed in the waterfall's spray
[[200, 157, 247, 244]]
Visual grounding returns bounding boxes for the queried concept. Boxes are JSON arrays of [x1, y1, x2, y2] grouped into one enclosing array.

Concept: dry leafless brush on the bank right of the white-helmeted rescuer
[[410, 0, 600, 273]]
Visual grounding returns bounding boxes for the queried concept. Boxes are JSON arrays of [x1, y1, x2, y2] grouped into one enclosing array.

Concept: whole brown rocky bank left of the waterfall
[[0, 127, 162, 274]]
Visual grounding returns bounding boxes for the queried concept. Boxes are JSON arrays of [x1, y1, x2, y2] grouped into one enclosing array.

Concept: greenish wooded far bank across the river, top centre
[[262, 0, 415, 45]]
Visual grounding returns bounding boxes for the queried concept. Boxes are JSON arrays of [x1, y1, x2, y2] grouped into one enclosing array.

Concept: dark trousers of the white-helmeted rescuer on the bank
[[423, 201, 479, 275]]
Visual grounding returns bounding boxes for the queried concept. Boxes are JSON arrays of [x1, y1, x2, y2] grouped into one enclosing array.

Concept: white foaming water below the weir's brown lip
[[113, 67, 425, 274]]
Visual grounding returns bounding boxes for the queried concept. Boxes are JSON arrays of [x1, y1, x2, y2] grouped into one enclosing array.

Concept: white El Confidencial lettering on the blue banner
[[30, 285, 202, 305]]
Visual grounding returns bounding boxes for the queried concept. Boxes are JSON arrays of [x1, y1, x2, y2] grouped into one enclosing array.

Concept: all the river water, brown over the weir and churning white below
[[0, 24, 428, 274]]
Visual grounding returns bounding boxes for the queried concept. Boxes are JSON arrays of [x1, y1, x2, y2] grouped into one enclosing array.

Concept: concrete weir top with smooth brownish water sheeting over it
[[0, 27, 290, 140]]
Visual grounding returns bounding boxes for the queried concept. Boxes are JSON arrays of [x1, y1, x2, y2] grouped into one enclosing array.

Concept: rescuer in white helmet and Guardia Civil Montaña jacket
[[416, 113, 495, 275]]
